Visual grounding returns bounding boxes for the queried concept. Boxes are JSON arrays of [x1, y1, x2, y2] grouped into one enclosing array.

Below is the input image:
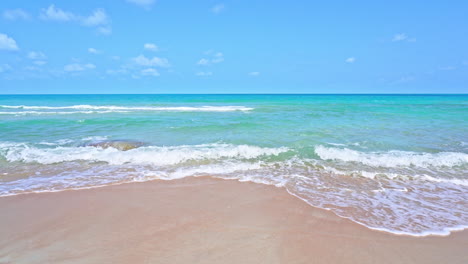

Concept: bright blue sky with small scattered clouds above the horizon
[[0, 0, 468, 94]]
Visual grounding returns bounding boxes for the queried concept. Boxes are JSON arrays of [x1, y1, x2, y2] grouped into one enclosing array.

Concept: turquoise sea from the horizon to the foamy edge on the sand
[[0, 95, 468, 235]]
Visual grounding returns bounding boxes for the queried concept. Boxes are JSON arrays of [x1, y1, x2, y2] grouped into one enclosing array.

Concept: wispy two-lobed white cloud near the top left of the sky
[[39, 5, 112, 35]]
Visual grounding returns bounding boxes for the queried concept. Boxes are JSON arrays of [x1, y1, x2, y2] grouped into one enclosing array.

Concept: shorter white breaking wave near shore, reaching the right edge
[[315, 145, 468, 168]]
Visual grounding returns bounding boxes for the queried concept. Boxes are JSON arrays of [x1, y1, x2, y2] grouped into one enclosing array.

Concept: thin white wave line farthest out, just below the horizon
[[0, 105, 254, 114]]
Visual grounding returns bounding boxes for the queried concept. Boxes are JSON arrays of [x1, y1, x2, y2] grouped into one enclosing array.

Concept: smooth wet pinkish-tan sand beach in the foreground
[[0, 177, 468, 264]]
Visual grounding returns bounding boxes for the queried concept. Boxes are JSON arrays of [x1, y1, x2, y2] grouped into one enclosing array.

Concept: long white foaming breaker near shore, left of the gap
[[0, 144, 289, 166]]
